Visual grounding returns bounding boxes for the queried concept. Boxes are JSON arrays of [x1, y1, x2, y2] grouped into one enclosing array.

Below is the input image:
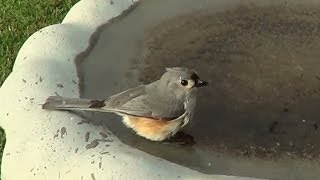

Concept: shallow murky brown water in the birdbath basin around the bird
[[77, 0, 320, 179]]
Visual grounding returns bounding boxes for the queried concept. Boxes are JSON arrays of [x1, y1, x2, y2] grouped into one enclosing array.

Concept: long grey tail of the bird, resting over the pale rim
[[42, 96, 105, 111]]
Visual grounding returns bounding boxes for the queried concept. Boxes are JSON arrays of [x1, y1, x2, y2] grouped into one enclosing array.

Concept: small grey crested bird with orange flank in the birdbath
[[42, 67, 208, 141]]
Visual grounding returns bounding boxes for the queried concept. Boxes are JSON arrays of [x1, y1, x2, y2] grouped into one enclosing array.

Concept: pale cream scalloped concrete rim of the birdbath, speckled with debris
[[0, 0, 262, 180]]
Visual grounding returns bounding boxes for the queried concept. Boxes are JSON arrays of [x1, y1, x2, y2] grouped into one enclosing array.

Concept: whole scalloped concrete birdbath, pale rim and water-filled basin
[[0, 0, 320, 180]]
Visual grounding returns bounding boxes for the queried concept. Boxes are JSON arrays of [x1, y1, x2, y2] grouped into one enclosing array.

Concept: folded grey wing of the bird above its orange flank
[[105, 85, 185, 120]]
